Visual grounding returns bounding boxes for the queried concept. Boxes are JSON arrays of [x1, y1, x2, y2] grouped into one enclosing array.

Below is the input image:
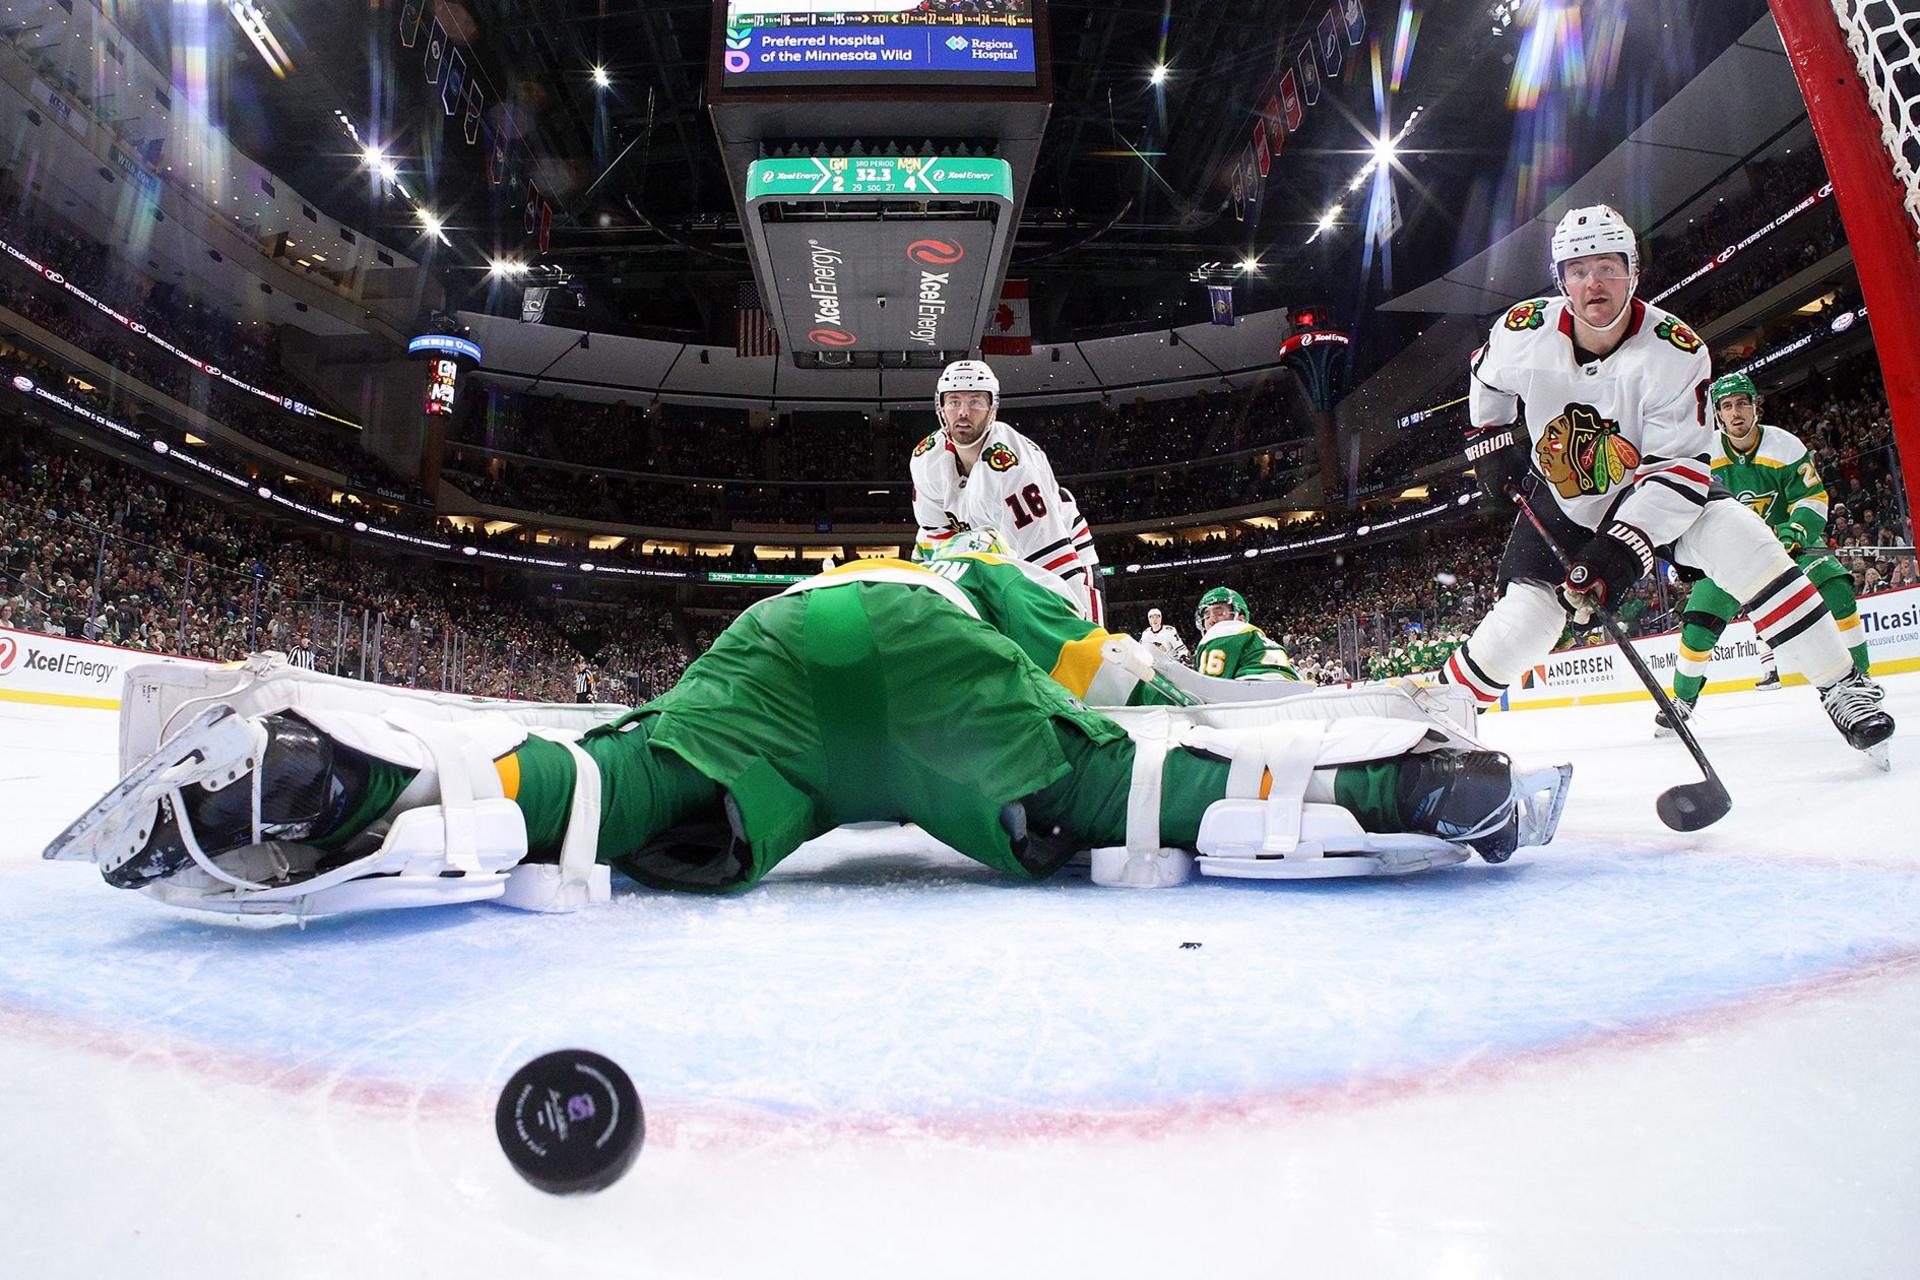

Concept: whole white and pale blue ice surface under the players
[[0, 676, 1920, 1278]]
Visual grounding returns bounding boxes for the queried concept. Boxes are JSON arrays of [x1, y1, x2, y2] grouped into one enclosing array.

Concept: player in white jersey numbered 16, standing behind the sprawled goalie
[[910, 361, 1106, 622]]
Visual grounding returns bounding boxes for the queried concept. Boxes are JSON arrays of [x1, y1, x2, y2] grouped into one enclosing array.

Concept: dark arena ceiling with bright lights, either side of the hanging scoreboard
[[210, 0, 1766, 353]]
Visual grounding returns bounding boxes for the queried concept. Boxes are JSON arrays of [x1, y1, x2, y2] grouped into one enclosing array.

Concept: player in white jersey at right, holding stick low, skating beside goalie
[[1446, 205, 1893, 766]]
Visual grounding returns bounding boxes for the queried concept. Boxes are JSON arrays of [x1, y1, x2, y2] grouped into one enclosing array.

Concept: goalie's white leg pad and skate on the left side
[[44, 702, 609, 915]]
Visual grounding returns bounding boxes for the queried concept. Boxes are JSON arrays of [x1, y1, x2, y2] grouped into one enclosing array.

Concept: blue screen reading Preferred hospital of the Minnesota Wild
[[718, 0, 1041, 92]]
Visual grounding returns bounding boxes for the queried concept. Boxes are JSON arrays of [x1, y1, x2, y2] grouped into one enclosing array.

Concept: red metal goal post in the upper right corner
[[1768, 0, 1920, 520]]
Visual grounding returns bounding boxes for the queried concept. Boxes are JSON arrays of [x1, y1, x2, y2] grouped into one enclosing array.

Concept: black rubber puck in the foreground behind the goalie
[[493, 1050, 647, 1196]]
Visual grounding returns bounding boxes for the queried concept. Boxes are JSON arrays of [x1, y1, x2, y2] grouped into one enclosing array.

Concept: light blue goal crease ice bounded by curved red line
[[0, 846, 1920, 1117]]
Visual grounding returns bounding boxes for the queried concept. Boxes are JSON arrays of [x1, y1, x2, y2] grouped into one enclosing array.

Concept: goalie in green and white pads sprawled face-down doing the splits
[[46, 549, 1569, 913]]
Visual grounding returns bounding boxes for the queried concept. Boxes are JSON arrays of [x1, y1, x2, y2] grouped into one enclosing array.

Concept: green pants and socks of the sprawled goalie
[[345, 574, 1443, 892]]
